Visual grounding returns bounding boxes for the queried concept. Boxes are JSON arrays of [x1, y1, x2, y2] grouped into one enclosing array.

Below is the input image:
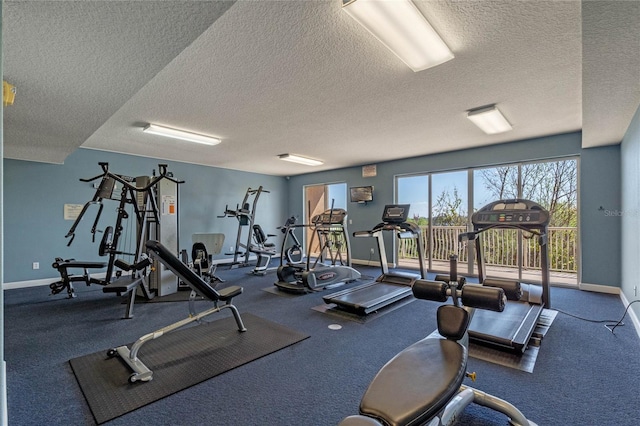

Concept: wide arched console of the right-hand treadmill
[[471, 199, 549, 226]]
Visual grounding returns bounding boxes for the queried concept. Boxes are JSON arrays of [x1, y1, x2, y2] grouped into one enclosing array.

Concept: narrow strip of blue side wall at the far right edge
[[614, 107, 640, 317]]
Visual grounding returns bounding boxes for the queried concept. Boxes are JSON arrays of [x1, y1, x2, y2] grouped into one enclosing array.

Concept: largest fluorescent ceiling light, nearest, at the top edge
[[342, 0, 453, 72]]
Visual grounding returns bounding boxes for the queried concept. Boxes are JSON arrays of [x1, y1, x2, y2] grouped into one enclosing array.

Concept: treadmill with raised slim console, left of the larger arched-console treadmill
[[322, 204, 426, 316]]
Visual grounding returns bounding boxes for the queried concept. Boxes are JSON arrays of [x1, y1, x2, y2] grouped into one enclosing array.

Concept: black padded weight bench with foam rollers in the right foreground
[[339, 256, 536, 426]]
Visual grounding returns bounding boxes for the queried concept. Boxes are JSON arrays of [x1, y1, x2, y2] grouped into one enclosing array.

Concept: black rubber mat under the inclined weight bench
[[69, 313, 309, 424]]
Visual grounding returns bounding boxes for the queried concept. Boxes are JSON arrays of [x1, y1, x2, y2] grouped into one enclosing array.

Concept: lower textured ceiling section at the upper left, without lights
[[2, 1, 233, 163]]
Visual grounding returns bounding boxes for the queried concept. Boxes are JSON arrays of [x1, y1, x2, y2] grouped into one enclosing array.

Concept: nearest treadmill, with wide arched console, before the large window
[[463, 199, 551, 354]]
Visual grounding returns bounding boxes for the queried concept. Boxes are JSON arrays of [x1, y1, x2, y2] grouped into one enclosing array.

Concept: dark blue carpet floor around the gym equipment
[[4, 268, 640, 426]]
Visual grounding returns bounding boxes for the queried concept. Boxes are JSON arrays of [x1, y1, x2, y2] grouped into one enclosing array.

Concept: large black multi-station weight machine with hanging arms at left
[[49, 163, 183, 318]]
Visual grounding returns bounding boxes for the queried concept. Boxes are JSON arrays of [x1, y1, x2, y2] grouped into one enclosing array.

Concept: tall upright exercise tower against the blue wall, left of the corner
[[218, 185, 269, 269]]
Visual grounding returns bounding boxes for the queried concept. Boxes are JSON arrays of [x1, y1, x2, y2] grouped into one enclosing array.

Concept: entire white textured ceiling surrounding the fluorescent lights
[[3, 0, 640, 176]]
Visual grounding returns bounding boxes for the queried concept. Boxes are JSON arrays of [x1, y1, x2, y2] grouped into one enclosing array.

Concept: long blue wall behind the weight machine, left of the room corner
[[4, 149, 288, 283]]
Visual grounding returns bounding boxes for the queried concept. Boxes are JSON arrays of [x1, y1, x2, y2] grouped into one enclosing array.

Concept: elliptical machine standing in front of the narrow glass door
[[275, 208, 361, 293]]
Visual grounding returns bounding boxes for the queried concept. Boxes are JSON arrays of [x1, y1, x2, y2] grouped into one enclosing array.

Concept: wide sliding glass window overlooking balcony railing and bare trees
[[396, 158, 578, 285]]
